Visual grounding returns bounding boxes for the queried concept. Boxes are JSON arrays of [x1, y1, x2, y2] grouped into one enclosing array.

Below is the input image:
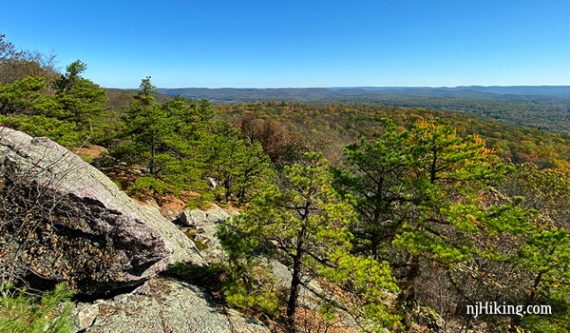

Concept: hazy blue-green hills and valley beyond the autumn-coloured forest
[[152, 86, 570, 135]]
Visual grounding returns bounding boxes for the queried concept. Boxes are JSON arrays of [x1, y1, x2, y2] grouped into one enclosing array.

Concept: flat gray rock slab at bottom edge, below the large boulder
[[76, 278, 270, 333]]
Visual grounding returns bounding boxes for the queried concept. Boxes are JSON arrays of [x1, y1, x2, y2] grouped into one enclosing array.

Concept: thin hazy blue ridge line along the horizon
[[158, 86, 570, 102]]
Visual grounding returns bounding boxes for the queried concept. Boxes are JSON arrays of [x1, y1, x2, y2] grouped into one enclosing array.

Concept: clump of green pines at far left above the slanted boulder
[[0, 62, 106, 148]]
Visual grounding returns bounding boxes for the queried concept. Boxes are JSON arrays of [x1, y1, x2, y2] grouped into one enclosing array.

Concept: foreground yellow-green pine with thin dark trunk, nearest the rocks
[[224, 153, 397, 328]]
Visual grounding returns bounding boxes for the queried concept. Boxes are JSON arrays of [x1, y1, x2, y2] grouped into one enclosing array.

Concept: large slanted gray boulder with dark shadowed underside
[[0, 127, 204, 294]]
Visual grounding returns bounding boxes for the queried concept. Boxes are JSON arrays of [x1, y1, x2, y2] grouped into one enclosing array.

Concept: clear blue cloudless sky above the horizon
[[0, 0, 570, 88]]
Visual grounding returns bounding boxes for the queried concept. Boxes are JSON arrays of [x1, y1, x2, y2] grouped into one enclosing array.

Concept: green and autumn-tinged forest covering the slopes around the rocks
[[0, 36, 570, 332]]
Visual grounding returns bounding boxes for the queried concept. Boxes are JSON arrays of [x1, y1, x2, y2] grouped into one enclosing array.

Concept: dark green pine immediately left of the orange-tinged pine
[[333, 119, 413, 260]]
